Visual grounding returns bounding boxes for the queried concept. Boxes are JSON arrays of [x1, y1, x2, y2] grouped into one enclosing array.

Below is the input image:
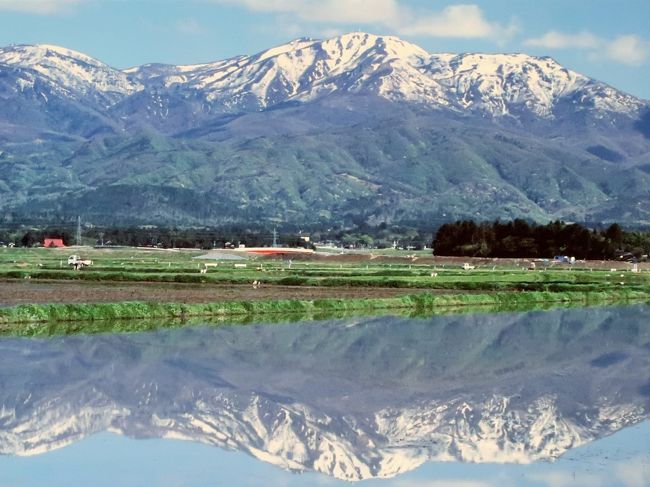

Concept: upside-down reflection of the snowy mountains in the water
[[0, 306, 650, 480]]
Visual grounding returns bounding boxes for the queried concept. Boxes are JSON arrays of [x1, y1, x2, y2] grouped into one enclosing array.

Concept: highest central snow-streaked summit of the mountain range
[[153, 33, 446, 110]]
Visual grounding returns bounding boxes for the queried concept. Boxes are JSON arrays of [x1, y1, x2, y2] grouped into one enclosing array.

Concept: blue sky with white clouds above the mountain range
[[0, 0, 650, 99]]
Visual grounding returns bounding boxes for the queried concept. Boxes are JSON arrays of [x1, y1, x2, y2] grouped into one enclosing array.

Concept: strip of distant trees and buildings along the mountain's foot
[[0, 220, 650, 262]]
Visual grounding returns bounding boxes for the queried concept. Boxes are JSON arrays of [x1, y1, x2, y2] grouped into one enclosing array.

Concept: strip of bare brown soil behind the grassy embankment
[[0, 280, 438, 306]]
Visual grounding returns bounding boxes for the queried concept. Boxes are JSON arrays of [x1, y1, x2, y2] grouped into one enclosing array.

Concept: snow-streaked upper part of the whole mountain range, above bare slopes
[[0, 33, 643, 118]]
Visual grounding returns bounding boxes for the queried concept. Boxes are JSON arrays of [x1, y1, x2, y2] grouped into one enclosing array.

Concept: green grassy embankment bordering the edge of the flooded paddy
[[0, 290, 650, 336]]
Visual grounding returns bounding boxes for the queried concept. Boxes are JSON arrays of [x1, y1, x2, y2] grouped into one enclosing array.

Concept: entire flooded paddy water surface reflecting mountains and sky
[[0, 305, 650, 487]]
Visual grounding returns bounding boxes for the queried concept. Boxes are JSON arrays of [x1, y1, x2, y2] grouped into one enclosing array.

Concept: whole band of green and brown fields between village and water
[[0, 247, 650, 330]]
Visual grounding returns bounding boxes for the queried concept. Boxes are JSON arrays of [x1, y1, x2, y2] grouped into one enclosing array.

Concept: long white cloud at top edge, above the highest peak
[[214, 0, 517, 40]]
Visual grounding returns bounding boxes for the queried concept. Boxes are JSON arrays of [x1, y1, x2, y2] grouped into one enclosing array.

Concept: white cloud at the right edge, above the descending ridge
[[524, 30, 650, 66]]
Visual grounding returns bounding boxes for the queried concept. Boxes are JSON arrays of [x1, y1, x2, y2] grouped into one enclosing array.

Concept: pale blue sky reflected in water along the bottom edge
[[0, 428, 650, 487]]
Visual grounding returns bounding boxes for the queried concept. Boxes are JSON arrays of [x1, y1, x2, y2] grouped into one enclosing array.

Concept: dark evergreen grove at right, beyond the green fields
[[433, 220, 650, 259]]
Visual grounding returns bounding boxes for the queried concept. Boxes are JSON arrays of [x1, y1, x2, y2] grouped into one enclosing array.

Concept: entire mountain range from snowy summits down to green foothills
[[0, 33, 650, 228]]
